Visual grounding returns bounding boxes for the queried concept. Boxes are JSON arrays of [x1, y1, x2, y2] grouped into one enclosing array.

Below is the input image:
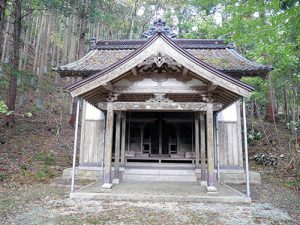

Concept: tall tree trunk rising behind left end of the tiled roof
[[69, 0, 89, 127]]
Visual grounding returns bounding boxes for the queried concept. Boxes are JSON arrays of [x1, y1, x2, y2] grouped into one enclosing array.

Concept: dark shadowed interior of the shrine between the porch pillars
[[113, 112, 206, 163]]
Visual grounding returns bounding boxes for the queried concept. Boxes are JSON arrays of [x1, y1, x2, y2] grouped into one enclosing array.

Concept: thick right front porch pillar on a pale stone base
[[206, 101, 217, 192]]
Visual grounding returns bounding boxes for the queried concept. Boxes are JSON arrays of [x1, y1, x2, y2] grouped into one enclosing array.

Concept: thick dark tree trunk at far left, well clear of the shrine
[[6, 0, 22, 126]]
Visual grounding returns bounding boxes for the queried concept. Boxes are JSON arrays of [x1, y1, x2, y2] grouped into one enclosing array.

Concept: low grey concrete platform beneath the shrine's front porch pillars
[[70, 181, 251, 203]]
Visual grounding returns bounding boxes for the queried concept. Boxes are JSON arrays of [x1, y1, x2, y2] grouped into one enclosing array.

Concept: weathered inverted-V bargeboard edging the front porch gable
[[68, 33, 253, 97]]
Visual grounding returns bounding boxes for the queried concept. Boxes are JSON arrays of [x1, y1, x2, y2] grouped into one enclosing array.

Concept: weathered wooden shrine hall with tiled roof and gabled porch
[[56, 20, 270, 195]]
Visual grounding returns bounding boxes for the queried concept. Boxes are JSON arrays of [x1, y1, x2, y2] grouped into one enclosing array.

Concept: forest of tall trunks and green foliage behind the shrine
[[0, 0, 300, 185]]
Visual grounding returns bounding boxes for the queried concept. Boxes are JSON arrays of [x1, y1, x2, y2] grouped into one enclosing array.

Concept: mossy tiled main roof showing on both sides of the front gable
[[56, 39, 272, 78]]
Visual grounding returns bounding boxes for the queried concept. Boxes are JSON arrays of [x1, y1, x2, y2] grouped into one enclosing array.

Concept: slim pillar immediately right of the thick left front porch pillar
[[113, 111, 121, 184]]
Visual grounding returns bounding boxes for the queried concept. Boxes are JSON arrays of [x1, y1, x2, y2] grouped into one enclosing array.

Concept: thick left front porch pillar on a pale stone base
[[102, 102, 114, 189]]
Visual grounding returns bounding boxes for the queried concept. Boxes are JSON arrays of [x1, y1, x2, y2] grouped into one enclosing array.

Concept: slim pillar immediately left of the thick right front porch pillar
[[200, 114, 207, 186]]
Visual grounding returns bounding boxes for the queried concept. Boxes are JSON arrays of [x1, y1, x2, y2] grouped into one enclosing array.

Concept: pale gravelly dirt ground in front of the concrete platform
[[0, 178, 300, 225]]
